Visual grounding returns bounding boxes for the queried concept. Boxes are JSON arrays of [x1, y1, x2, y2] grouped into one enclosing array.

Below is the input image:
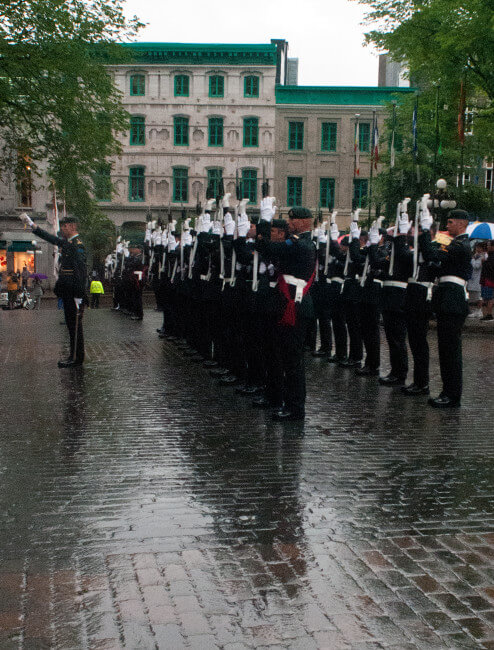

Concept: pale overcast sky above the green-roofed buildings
[[125, 0, 378, 86]]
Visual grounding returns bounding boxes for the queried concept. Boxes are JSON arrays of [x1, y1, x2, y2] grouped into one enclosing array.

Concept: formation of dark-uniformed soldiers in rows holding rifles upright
[[106, 189, 471, 421]]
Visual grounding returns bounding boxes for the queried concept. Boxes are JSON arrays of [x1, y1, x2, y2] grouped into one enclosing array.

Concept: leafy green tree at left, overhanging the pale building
[[0, 0, 142, 248]]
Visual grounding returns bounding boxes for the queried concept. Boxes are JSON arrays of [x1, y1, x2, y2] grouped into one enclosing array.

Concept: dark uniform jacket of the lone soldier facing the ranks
[[33, 228, 86, 298]]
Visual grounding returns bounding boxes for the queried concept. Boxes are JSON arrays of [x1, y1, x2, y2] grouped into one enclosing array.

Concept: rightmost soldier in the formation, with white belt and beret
[[419, 210, 472, 408]]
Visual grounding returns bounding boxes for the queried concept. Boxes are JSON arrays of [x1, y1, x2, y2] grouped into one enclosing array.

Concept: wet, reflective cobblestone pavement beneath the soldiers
[[0, 310, 494, 650]]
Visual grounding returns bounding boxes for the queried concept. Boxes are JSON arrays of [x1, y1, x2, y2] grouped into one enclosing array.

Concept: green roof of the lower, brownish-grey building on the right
[[276, 86, 415, 106]]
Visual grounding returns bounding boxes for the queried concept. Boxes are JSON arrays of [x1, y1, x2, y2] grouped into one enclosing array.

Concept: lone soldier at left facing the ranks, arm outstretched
[[20, 214, 86, 368]]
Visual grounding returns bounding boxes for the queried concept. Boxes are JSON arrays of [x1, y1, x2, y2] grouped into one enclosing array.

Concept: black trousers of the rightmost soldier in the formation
[[437, 314, 465, 400]]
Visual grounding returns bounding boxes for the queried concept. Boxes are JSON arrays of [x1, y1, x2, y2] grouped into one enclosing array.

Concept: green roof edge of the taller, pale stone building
[[117, 43, 276, 65]]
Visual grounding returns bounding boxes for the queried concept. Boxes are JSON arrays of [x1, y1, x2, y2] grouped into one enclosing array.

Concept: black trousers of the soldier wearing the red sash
[[274, 316, 312, 415]]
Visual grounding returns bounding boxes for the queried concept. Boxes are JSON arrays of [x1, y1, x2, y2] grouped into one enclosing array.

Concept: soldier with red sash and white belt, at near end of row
[[256, 208, 316, 421]]
